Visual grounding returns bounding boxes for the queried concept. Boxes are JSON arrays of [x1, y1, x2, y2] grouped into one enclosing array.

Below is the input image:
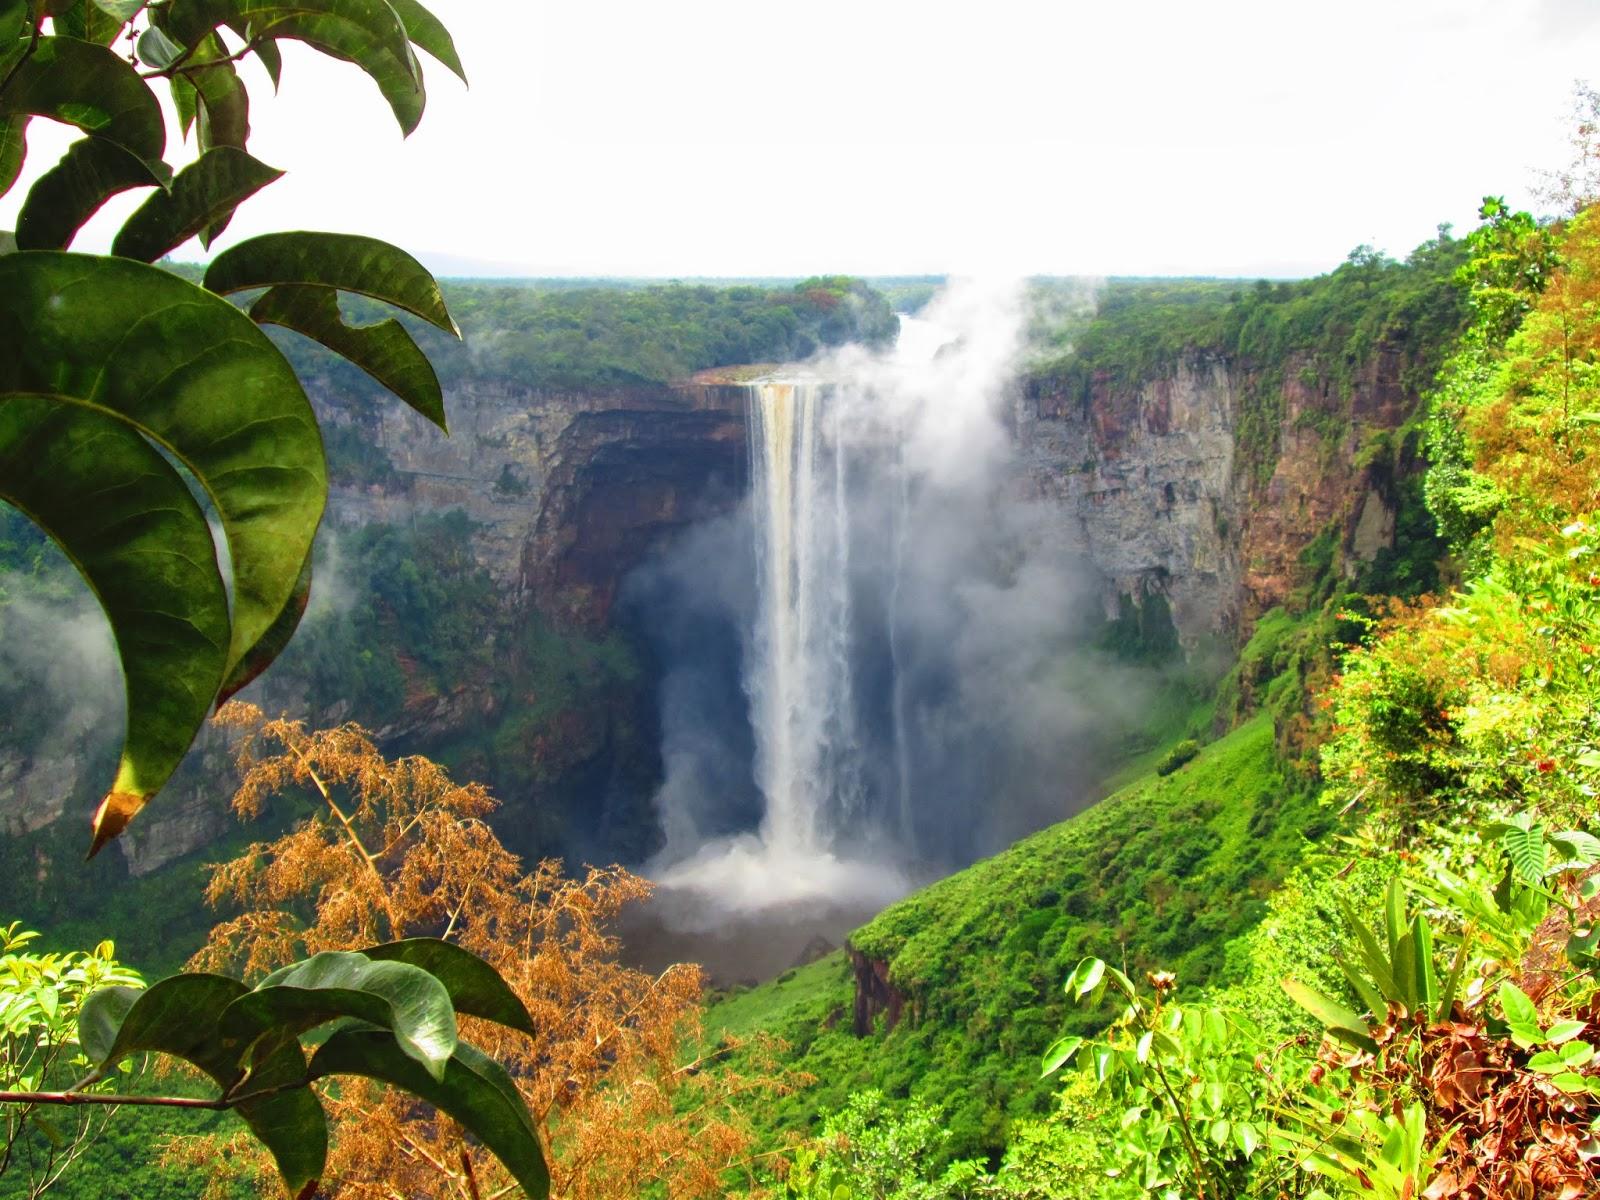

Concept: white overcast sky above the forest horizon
[[9, 0, 1600, 277]]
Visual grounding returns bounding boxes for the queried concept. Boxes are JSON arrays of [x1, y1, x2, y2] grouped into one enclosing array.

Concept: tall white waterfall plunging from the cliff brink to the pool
[[636, 293, 1014, 933]]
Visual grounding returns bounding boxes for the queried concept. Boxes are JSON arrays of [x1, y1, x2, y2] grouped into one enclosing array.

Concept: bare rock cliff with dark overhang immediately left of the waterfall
[[321, 381, 746, 629]]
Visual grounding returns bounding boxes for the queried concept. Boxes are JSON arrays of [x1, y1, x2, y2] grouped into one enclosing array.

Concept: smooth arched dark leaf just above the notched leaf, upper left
[[205, 234, 459, 336]]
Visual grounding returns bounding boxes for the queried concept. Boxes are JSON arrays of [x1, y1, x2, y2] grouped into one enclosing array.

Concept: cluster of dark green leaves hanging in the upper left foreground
[[0, 0, 464, 853]]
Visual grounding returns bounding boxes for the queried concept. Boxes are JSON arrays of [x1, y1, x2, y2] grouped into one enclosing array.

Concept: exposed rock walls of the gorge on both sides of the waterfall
[[0, 334, 1416, 874]]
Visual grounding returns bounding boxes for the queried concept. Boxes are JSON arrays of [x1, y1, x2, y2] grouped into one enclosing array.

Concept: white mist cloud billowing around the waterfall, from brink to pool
[[624, 280, 1171, 953]]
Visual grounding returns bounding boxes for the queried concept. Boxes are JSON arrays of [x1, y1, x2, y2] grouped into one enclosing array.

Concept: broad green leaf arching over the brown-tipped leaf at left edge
[[0, 251, 328, 850]]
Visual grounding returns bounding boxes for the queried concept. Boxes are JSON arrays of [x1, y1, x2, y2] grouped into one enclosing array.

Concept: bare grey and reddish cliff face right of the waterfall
[[1013, 350, 1418, 645]]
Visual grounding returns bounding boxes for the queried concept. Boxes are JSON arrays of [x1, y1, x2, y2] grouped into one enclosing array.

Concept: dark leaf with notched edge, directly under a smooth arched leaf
[[250, 283, 448, 432]]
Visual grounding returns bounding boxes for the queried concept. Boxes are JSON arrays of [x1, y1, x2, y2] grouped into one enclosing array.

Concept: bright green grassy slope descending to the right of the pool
[[706, 715, 1322, 1157]]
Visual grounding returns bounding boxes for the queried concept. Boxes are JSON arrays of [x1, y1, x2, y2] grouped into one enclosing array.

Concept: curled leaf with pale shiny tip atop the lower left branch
[[221, 950, 456, 1078]]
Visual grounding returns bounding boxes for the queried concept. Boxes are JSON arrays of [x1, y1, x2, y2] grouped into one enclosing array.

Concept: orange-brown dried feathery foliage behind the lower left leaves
[[174, 702, 781, 1200]]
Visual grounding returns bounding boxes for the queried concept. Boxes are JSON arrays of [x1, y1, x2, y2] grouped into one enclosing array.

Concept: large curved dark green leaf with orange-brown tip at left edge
[[0, 400, 229, 851]]
